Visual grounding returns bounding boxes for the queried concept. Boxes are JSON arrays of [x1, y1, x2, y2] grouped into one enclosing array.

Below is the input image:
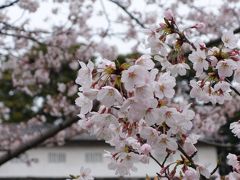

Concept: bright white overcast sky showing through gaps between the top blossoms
[[1, 0, 236, 53]]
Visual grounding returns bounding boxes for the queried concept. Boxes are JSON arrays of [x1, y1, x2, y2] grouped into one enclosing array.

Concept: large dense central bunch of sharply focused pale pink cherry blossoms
[[76, 55, 201, 175]]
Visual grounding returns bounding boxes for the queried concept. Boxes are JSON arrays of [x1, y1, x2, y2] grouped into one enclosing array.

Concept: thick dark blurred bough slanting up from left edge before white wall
[[0, 118, 78, 166]]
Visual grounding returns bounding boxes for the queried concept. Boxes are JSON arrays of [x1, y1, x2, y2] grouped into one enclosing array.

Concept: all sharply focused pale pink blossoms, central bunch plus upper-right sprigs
[[76, 11, 240, 179]]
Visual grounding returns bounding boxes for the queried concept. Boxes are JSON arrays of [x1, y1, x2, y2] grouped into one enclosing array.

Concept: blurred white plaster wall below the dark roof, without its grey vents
[[0, 146, 217, 177]]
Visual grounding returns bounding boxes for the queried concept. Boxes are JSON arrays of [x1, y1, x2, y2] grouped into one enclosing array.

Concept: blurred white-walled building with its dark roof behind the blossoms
[[0, 134, 217, 180]]
